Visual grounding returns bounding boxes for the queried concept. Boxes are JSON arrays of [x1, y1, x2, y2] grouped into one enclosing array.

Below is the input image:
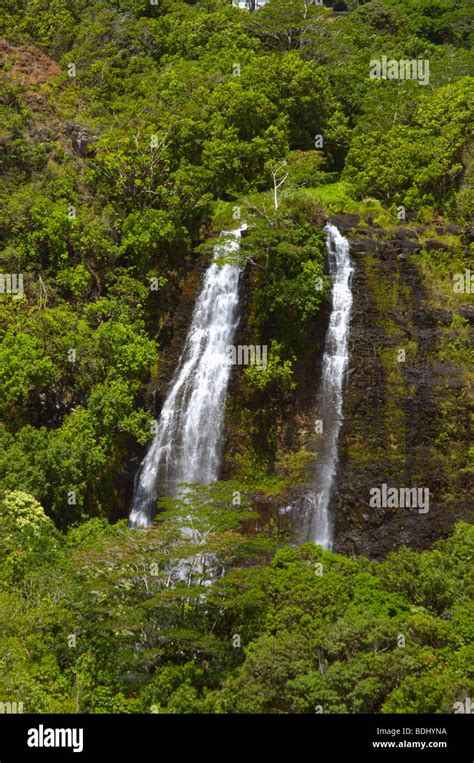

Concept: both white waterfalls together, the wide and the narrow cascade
[[130, 224, 353, 548]]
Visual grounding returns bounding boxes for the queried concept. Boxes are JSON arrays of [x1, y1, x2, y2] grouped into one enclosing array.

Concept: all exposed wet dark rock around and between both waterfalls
[[121, 215, 474, 558]]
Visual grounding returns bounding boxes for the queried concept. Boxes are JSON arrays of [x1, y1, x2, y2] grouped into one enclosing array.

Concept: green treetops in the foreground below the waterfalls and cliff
[[0, 484, 474, 713]]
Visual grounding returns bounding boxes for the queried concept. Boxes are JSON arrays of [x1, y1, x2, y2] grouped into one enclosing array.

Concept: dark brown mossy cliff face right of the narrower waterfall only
[[332, 217, 474, 557]]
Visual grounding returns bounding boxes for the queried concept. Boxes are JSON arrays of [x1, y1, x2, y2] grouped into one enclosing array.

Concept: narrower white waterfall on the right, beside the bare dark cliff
[[301, 223, 354, 548]]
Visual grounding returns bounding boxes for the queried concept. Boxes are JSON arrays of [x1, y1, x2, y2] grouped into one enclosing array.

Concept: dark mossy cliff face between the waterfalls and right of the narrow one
[[223, 215, 474, 558]]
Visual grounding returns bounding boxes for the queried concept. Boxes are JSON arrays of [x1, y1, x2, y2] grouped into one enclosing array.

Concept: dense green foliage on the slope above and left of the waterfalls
[[0, 0, 472, 526]]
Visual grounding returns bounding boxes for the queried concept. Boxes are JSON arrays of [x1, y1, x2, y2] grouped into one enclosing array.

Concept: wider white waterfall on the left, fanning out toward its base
[[130, 224, 247, 527]]
